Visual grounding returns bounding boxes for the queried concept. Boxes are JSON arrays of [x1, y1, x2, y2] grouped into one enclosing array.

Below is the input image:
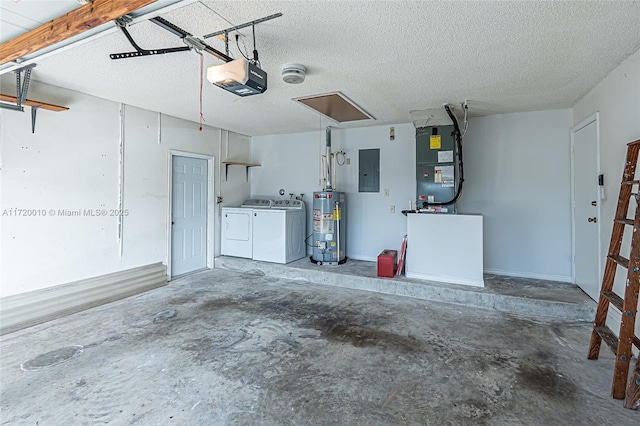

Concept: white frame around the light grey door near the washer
[[167, 149, 216, 281]]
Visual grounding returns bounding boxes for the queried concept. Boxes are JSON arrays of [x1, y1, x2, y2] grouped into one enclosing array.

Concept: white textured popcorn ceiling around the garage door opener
[[3, 0, 640, 135]]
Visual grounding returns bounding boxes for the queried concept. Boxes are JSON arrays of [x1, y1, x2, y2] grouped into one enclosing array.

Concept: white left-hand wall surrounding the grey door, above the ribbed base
[[0, 76, 249, 297]]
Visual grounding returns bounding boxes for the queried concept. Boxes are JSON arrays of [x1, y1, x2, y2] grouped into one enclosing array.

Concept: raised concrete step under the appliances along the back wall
[[215, 256, 596, 322]]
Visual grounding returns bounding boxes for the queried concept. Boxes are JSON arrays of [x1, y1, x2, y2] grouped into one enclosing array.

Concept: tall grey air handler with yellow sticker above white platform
[[416, 125, 458, 213]]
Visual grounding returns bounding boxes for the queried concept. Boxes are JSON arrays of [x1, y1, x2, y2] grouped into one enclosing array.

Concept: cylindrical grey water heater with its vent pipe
[[311, 127, 347, 265]]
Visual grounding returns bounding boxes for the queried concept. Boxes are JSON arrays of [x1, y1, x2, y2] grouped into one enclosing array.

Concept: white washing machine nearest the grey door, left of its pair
[[220, 198, 272, 259]]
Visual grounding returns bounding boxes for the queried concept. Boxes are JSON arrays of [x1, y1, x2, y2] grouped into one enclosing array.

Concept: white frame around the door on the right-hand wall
[[571, 112, 603, 284]]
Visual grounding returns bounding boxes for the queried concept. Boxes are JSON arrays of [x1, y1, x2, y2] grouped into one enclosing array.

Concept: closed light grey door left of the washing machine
[[171, 156, 207, 277]]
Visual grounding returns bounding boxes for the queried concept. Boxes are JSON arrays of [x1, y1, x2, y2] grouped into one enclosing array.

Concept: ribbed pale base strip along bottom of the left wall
[[0, 263, 167, 335]]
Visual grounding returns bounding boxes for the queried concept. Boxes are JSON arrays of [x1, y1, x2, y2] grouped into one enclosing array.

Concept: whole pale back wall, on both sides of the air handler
[[251, 110, 571, 281]]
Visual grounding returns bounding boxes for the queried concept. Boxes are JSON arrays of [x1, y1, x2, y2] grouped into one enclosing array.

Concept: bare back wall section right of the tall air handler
[[459, 109, 571, 282]]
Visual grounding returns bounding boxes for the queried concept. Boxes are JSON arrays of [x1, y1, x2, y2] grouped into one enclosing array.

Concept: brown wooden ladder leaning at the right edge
[[588, 140, 640, 408]]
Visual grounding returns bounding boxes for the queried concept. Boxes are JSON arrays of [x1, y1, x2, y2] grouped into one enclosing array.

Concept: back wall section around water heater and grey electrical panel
[[251, 124, 415, 261]]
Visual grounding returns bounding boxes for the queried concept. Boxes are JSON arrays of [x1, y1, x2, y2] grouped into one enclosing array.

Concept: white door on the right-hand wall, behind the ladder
[[572, 120, 600, 300]]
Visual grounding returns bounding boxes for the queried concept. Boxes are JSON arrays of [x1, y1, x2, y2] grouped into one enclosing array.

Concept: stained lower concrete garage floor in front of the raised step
[[0, 269, 640, 425]]
